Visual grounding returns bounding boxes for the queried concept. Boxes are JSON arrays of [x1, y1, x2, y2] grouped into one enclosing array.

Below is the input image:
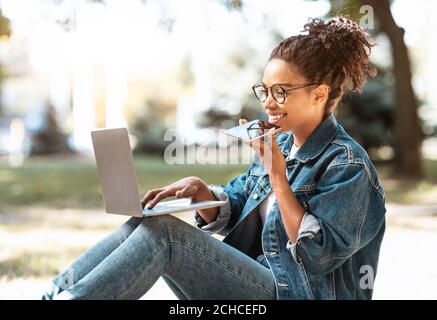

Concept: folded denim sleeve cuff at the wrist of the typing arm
[[194, 185, 231, 234]]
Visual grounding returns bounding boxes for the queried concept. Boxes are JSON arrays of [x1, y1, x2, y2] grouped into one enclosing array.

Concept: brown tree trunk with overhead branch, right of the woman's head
[[330, 0, 424, 179]]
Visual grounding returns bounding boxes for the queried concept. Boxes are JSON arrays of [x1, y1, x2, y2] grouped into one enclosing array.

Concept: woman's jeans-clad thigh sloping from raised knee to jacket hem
[[160, 218, 276, 300]]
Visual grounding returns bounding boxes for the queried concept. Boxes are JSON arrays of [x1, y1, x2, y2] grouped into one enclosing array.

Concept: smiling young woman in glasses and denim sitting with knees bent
[[43, 17, 385, 299]]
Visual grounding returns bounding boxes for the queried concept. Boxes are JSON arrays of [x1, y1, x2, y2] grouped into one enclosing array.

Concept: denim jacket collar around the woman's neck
[[280, 113, 338, 163]]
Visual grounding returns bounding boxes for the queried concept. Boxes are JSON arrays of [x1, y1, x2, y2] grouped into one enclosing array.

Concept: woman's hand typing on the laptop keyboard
[[141, 177, 208, 209]]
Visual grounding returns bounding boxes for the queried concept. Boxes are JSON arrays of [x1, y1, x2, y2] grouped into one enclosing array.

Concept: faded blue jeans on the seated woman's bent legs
[[42, 215, 276, 300]]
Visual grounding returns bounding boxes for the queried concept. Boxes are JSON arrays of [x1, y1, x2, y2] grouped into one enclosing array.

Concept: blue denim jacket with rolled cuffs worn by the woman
[[196, 114, 386, 299]]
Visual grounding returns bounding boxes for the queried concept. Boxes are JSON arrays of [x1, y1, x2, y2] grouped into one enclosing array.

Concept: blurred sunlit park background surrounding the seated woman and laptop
[[0, 0, 437, 299]]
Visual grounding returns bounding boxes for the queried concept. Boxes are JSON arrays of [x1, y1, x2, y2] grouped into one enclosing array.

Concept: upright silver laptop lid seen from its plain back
[[91, 128, 142, 217]]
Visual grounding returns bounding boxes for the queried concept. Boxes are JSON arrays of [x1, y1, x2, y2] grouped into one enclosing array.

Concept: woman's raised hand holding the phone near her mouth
[[239, 119, 287, 183]]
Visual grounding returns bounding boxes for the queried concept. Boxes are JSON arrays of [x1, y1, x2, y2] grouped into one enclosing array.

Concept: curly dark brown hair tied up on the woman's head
[[269, 16, 376, 115]]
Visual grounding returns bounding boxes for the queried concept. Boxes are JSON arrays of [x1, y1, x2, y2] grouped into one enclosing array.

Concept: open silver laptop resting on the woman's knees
[[91, 128, 226, 217]]
